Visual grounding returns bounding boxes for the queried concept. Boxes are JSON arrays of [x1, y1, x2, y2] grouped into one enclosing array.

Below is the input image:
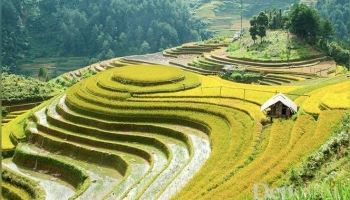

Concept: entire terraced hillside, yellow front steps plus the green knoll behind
[[1, 4, 350, 200]]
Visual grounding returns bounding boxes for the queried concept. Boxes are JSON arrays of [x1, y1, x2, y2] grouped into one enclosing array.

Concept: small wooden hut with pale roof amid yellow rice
[[260, 93, 298, 119]]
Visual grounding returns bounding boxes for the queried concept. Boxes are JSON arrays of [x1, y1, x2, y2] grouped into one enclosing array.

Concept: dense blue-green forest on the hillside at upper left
[[2, 0, 211, 73]]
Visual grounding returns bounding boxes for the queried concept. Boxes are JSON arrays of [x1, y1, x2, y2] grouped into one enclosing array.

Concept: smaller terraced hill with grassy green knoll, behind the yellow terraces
[[163, 30, 337, 85]]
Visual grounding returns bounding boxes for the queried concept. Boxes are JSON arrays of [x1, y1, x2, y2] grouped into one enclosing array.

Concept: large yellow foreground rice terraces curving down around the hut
[[5, 61, 348, 199]]
